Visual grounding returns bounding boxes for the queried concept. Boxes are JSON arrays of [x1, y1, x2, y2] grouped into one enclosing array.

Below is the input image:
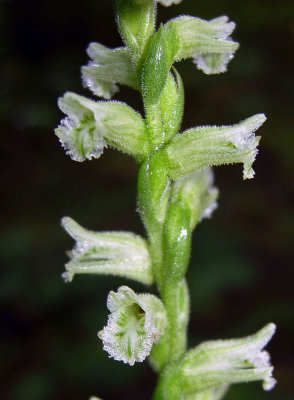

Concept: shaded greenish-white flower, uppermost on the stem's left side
[[82, 43, 138, 99]]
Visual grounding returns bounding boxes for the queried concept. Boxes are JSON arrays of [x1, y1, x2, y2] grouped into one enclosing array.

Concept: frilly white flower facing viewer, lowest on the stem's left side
[[98, 286, 167, 365]]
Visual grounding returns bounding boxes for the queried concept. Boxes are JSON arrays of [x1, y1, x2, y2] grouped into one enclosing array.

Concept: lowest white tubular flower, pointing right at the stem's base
[[181, 324, 276, 395]]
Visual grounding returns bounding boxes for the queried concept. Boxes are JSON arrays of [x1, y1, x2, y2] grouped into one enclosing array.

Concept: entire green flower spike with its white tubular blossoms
[[55, 0, 275, 400]]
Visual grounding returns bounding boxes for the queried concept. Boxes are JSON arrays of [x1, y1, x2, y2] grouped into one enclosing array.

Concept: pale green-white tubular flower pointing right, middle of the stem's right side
[[166, 114, 266, 179]]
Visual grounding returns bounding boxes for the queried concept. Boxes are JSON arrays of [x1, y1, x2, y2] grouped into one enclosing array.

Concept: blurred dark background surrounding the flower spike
[[0, 0, 294, 400]]
